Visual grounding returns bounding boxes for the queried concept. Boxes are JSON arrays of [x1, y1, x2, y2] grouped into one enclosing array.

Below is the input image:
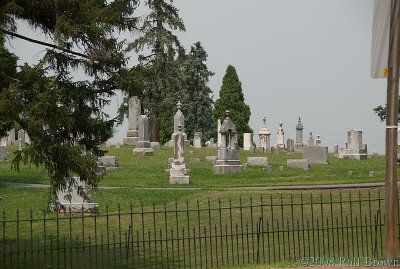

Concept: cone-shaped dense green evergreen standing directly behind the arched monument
[[213, 65, 253, 146]]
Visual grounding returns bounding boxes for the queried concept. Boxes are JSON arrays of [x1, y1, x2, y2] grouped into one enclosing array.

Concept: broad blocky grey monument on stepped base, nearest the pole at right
[[343, 129, 368, 160]]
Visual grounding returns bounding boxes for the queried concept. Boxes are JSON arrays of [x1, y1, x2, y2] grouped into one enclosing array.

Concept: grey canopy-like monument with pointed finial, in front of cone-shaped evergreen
[[213, 111, 243, 174]]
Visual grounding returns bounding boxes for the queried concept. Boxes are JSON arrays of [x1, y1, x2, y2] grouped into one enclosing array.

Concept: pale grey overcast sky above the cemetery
[[5, 0, 386, 153]]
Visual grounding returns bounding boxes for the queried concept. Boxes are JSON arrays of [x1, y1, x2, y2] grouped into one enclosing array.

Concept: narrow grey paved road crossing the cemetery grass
[[0, 179, 394, 191]]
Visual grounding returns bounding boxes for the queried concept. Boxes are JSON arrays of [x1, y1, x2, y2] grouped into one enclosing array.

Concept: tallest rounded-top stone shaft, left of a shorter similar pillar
[[122, 96, 141, 146]]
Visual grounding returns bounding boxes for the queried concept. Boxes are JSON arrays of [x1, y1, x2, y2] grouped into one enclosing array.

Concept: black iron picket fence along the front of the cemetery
[[0, 189, 394, 268]]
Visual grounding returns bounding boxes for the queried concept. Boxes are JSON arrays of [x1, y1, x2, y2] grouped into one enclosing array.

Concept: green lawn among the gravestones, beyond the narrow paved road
[[0, 146, 385, 189]]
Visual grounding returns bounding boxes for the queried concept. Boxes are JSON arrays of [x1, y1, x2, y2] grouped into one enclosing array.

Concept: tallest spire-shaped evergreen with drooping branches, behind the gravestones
[[128, 0, 185, 141]]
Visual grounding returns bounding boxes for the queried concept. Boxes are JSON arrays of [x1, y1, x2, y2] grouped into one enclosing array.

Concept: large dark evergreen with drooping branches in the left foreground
[[0, 0, 136, 201]]
